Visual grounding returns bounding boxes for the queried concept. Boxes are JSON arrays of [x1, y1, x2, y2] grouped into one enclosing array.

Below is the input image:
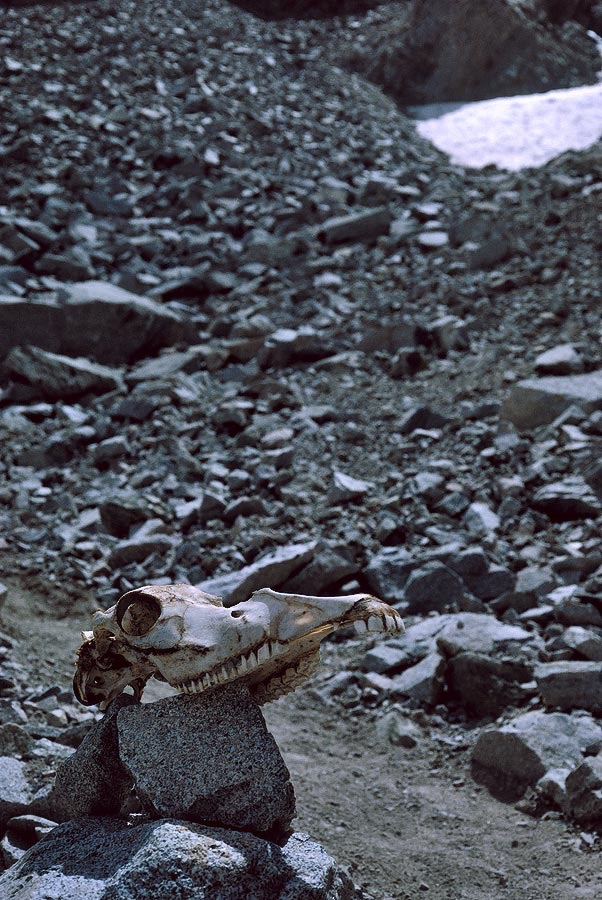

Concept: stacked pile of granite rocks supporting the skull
[[0, 684, 358, 900]]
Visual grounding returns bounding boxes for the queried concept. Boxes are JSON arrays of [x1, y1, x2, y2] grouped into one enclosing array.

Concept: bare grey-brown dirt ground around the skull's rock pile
[[0, 583, 602, 900]]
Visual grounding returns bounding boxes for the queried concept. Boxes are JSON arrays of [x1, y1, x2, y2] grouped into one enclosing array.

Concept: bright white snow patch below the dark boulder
[[410, 84, 602, 171]]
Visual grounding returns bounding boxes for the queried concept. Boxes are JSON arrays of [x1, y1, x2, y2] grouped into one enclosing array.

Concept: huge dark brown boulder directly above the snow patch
[[345, 0, 599, 104]]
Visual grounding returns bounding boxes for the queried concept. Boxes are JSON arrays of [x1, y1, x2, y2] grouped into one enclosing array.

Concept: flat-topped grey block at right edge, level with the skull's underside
[[535, 660, 602, 713]]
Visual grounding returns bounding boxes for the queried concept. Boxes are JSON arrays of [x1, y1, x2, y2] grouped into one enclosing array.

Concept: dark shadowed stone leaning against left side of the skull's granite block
[[43, 694, 135, 822]]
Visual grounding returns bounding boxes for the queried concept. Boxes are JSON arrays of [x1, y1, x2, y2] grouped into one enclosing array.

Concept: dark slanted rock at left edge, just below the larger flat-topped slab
[[3, 347, 124, 400]]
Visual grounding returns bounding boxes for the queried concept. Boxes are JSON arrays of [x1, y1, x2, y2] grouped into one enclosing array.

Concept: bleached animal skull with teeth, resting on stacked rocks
[[73, 584, 403, 708]]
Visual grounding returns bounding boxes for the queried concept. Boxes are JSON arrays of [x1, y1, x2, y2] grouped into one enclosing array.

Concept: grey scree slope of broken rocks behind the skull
[[0, 0, 602, 896]]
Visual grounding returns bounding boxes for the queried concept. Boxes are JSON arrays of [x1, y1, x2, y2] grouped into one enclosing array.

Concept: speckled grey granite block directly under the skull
[[117, 684, 295, 836]]
